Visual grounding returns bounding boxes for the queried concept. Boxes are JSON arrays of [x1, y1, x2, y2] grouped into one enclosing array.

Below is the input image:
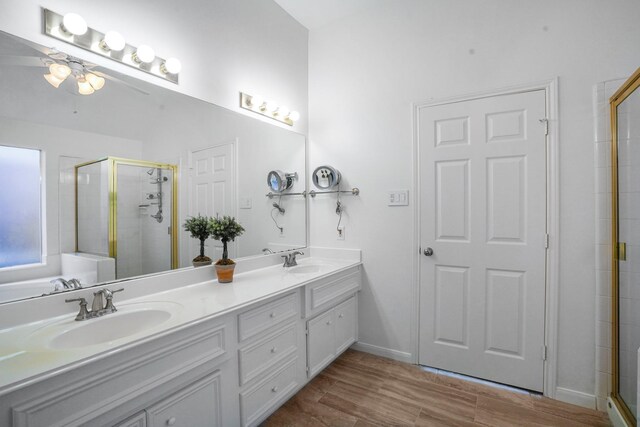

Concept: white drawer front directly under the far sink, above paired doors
[[305, 268, 361, 317]]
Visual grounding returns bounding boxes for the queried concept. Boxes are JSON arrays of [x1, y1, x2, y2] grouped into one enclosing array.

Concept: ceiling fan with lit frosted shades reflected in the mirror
[[0, 37, 148, 95]]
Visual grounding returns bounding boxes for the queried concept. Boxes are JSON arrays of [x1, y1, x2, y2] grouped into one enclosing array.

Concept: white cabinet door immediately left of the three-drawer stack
[[147, 371, 222, 427]]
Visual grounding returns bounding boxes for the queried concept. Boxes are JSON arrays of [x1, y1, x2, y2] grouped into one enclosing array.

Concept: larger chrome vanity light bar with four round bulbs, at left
[[42, 8, 182, 84]]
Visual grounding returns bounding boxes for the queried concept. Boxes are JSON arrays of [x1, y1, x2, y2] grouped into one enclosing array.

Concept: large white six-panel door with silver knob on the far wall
[[418, 91, 546, 391]]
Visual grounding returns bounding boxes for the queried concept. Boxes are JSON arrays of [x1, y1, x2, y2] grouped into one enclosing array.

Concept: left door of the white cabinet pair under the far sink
[[307, 309, 336, 377]]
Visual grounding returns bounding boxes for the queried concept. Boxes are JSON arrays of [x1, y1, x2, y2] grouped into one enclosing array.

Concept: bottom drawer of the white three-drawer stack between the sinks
[[240, 357, 298, 426]]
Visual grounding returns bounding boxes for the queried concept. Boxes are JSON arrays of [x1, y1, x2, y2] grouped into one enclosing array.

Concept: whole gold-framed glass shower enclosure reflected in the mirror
[[75, 157, 178, 279]]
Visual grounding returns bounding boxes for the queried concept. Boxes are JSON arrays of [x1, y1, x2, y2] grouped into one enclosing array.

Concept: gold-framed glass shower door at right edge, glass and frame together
[[611, 65, 640, 426]]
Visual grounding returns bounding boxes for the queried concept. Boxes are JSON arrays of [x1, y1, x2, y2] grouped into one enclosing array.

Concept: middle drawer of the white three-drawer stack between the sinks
[[238, 323, 298, 385]]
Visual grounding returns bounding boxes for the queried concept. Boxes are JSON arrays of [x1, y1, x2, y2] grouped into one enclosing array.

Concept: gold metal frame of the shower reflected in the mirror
[[75, 157, 179, 274]]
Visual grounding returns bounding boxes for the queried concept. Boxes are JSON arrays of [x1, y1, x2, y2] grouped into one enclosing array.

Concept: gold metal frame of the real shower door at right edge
[[609, 68, 640, 426]]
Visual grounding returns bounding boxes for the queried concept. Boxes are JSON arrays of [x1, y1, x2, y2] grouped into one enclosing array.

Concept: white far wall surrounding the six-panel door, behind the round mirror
[[309, 0, 640, 400]]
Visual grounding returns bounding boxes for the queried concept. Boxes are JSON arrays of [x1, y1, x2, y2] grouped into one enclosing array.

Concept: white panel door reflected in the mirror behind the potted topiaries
[[189, 143, 236, 260]]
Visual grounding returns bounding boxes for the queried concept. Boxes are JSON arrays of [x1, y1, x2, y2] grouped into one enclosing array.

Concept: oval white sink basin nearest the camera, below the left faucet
[[29, 302, 181, 350]]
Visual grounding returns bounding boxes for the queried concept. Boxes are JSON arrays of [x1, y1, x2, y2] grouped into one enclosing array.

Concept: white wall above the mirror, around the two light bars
[[0, 0, 308, 134]]
